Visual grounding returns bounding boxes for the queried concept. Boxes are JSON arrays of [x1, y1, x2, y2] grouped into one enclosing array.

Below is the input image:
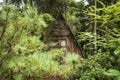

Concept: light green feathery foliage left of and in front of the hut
[[0, 6, 80, 80]]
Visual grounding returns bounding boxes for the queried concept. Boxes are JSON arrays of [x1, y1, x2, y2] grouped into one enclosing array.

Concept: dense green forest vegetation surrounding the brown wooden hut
[[0, 0, 120, 80]]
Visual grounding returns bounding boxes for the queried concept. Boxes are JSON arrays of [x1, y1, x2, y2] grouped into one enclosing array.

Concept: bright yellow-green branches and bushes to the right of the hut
[[78, 2, 120, 80]]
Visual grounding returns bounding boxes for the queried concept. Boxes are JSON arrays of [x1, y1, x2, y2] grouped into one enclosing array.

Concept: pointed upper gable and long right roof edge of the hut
[[52, 13, 85, 58]]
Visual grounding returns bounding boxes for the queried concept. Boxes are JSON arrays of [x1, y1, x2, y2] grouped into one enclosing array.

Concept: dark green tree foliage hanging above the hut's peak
[[10, 0, 69, 19]]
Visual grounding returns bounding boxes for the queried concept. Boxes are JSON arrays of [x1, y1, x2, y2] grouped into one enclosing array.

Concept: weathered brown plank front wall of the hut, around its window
[[51, 25, 81, 54]]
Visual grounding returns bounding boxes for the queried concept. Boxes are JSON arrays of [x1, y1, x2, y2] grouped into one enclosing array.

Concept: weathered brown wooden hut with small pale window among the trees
[[50, 23, 84, 58]]
